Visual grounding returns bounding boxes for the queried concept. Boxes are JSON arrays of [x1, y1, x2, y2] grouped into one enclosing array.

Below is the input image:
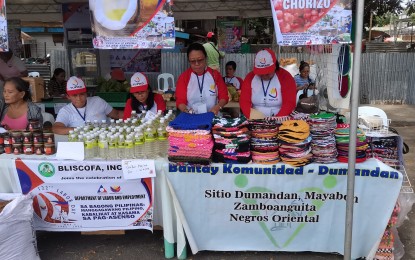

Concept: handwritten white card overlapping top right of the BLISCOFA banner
[[121, 160, 156, 180]]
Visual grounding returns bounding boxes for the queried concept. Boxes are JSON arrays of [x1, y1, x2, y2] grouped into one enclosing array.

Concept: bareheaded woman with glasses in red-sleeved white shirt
[[176, 43, 229, 115]]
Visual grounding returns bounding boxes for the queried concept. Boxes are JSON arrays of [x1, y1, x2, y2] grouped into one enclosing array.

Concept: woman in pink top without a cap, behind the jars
[[1, 77, 43, 130]]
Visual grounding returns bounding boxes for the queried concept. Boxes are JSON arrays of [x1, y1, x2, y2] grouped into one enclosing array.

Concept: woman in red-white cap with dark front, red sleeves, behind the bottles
[[124, 72, 166, 119]]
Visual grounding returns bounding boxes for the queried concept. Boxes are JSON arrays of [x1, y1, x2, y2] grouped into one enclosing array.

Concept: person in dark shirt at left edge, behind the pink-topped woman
[[0, 51, 28, 93]]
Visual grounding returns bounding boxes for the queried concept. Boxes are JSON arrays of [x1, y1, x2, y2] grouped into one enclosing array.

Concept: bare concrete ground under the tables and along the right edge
[[37, 105, 415, 260]]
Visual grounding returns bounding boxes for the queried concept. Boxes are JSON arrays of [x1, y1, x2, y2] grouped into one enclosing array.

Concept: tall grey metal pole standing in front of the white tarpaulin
[[343, 0, 365, 260]]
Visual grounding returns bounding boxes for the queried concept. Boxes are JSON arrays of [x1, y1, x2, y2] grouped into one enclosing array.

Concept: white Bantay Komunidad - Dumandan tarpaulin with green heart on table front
[[165, 159, 402, 258]]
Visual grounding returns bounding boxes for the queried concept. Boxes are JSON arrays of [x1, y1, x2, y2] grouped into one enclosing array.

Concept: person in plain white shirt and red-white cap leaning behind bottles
[[52, 76, 124, 135]]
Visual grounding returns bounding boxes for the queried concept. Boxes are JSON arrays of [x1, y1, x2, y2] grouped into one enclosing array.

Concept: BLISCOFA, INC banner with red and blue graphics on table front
[[15, 159, 153, 231]]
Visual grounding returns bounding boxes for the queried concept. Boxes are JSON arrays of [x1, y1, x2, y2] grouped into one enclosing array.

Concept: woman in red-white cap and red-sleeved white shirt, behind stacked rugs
[[239, 49, 296, 118]]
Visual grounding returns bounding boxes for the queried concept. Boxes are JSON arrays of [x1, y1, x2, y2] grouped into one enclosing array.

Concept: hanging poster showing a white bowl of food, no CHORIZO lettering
[[89, 0, 175, 49]]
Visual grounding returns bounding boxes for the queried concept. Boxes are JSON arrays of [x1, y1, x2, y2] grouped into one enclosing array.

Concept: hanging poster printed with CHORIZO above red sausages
[[270, 0, 352, 45]]
